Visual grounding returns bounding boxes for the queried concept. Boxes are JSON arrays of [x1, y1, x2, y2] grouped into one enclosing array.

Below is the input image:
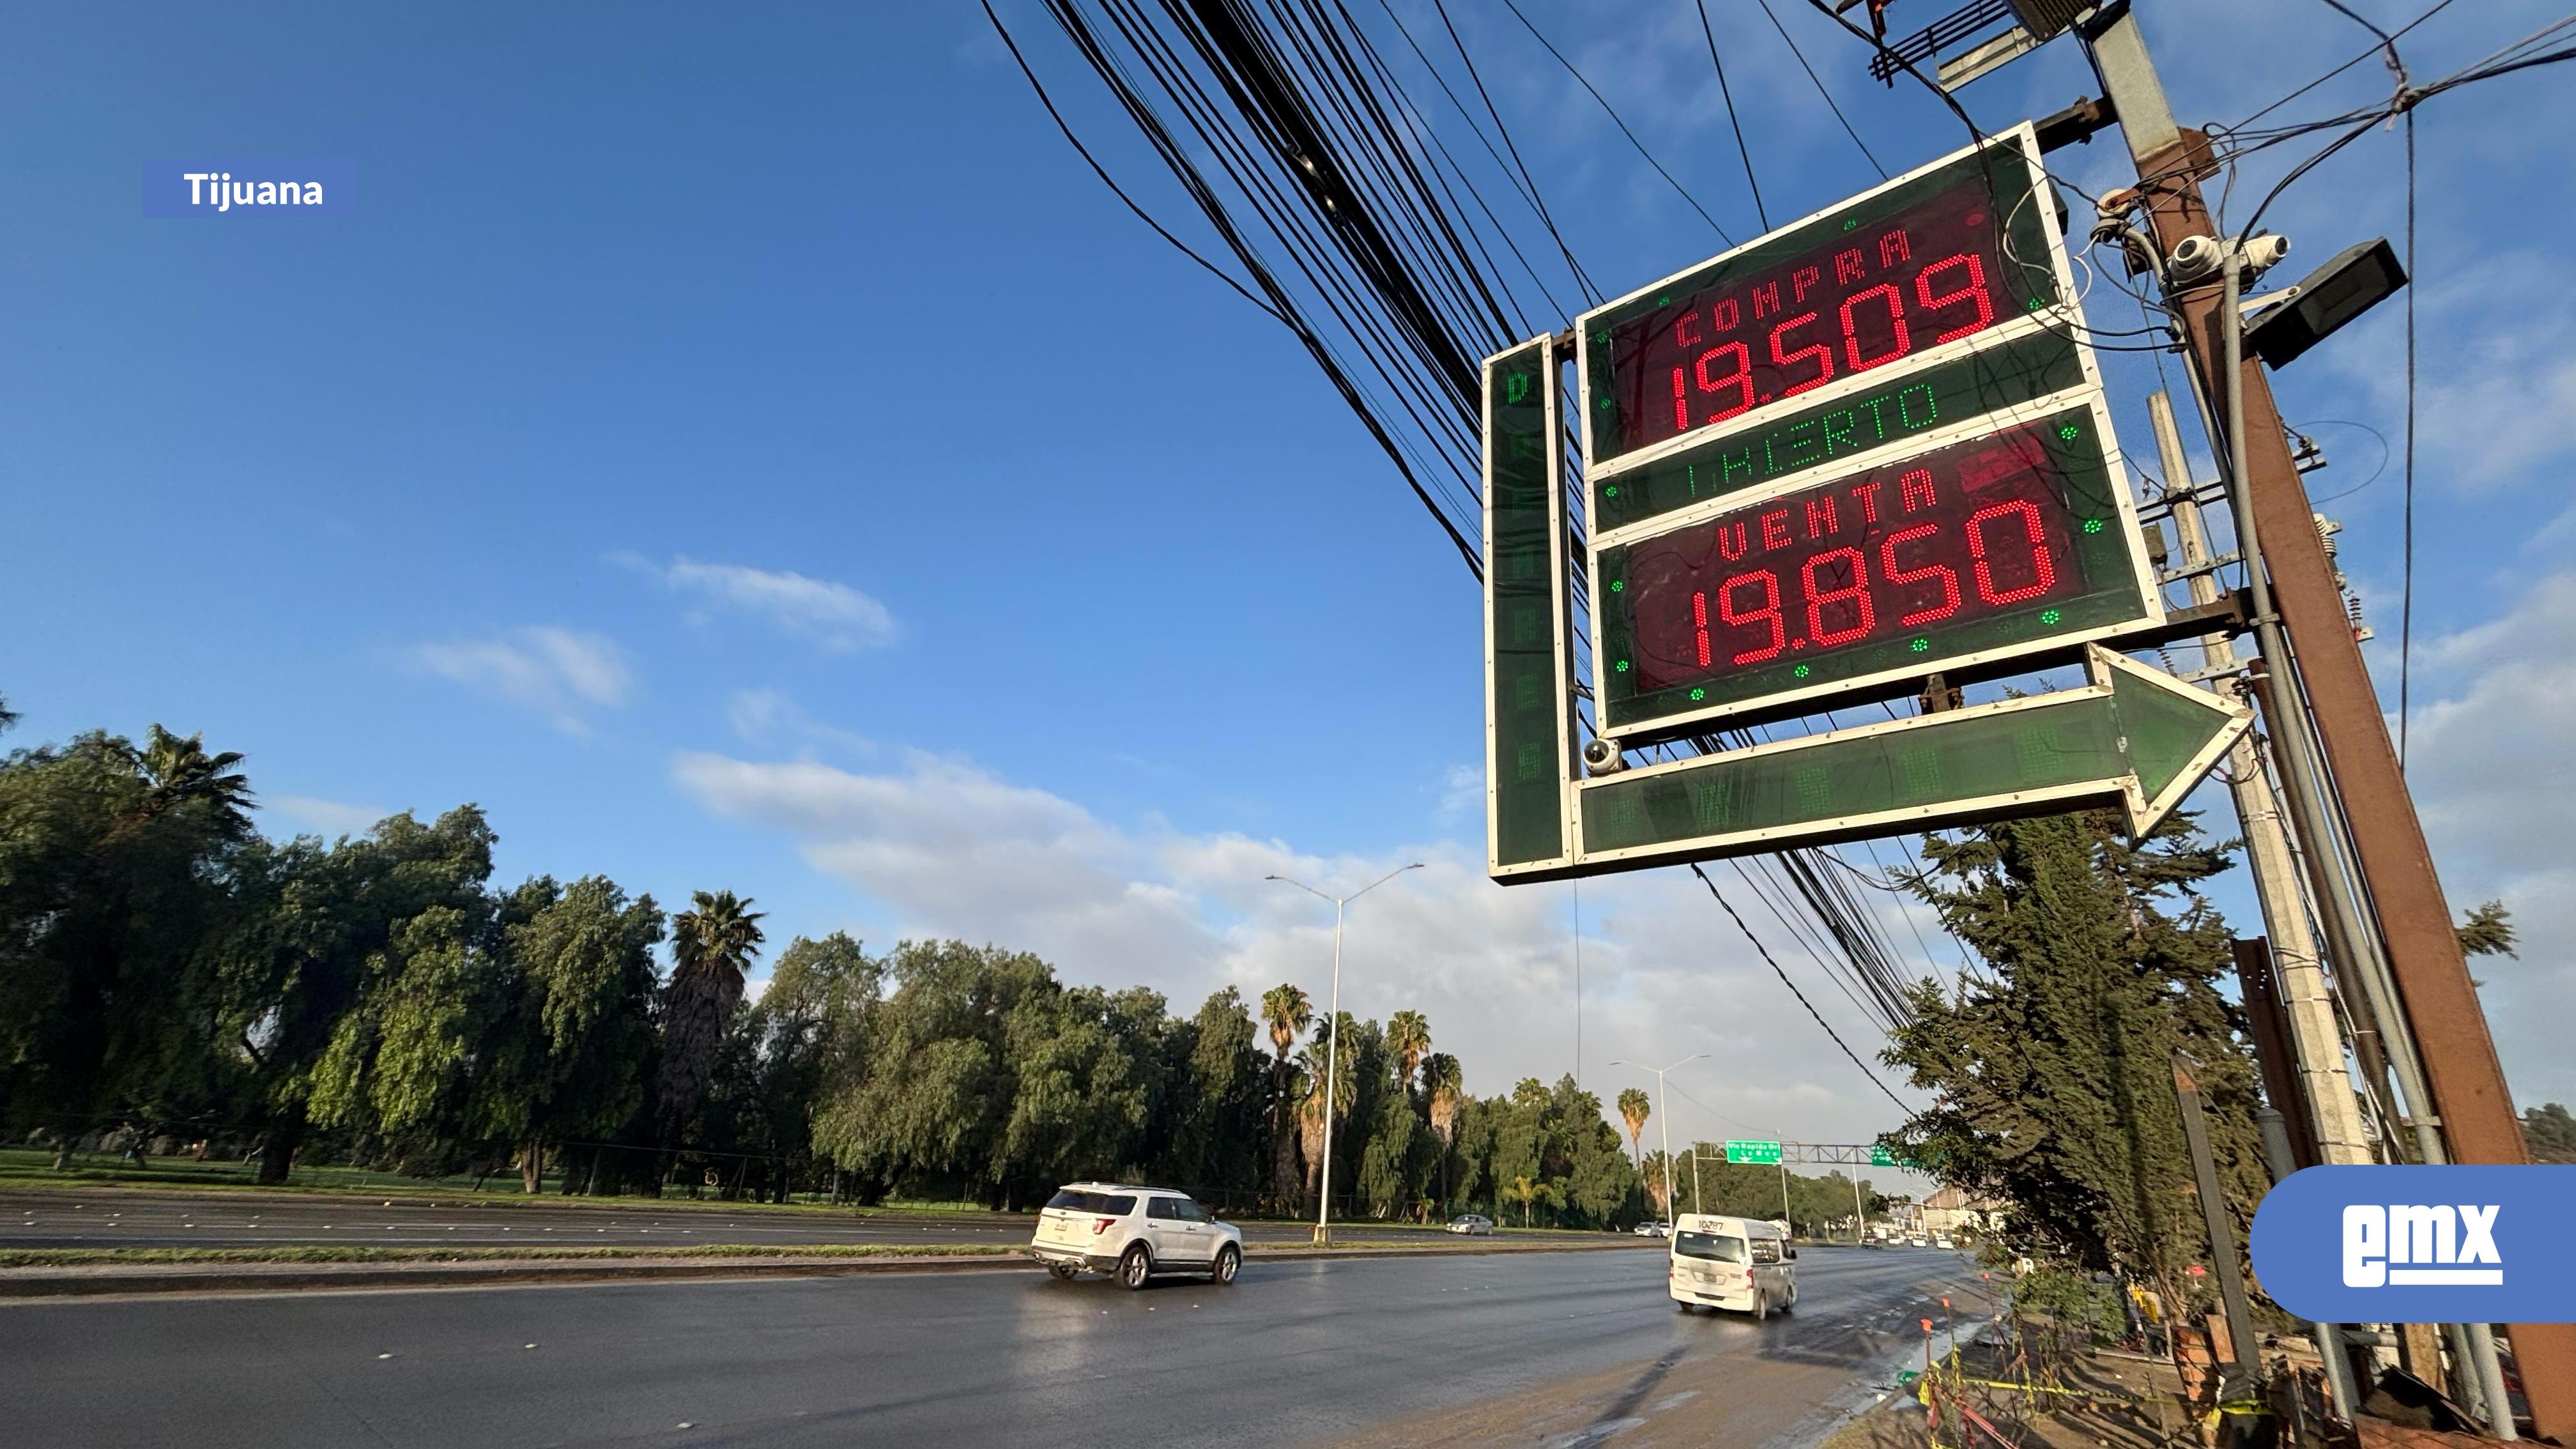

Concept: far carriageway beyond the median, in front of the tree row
[[0, 1188, 1445, 1248]]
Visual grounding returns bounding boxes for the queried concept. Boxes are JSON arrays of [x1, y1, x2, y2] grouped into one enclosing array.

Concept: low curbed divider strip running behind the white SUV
[[0, 1227, 1638, 1302]]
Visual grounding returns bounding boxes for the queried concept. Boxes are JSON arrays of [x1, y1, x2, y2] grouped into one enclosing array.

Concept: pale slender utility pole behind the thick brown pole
[[2146, 392, 2372, 1165]]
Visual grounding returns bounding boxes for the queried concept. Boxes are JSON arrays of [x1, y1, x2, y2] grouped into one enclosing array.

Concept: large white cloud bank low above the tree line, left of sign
[[672, 750, 1901, 1142]]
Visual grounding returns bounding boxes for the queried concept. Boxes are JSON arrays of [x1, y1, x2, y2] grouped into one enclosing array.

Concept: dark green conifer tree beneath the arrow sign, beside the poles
[[1885, 809, 2267, 1302]]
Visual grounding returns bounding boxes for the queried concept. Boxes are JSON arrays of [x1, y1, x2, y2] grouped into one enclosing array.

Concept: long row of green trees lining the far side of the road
[[0, 712, 1850, 1230]]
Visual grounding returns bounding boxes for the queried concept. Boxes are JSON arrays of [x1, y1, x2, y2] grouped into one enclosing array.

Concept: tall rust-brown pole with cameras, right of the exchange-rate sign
[[2084, 5, 2576, 1444]]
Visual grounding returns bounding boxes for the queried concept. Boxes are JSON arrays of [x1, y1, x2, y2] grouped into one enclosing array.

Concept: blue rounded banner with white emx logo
[[2254, 1165, 2576, 1322]]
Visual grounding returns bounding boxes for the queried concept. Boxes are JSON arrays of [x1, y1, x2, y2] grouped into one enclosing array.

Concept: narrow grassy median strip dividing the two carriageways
[[0, 1240, 1638, 1300]]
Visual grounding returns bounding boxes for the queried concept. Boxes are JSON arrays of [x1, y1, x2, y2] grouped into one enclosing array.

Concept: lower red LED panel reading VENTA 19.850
[[1600, 408, 2149, 730]]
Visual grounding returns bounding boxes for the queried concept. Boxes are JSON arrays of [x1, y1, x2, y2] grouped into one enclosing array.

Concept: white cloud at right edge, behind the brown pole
[[2406, 572, 2576, 1106]]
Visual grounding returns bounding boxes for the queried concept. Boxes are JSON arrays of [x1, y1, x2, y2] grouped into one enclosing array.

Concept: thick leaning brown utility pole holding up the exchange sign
[[2082, 14, 2576, 1441]]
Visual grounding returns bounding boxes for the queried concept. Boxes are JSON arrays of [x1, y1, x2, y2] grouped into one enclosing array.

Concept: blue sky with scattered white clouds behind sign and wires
[[0, 0, 2576, 1140]]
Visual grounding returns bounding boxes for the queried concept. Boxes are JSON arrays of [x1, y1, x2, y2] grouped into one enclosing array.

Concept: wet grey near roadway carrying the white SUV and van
[[0, 1250, 1974, 1449]]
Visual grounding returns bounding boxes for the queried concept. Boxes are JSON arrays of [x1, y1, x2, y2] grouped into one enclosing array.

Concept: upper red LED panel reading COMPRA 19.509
[[1582, 137, 2058, 461]]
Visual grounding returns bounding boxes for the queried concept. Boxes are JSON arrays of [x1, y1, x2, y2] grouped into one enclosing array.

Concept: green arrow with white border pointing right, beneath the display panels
[[1577, 645, 2254, 869]]
